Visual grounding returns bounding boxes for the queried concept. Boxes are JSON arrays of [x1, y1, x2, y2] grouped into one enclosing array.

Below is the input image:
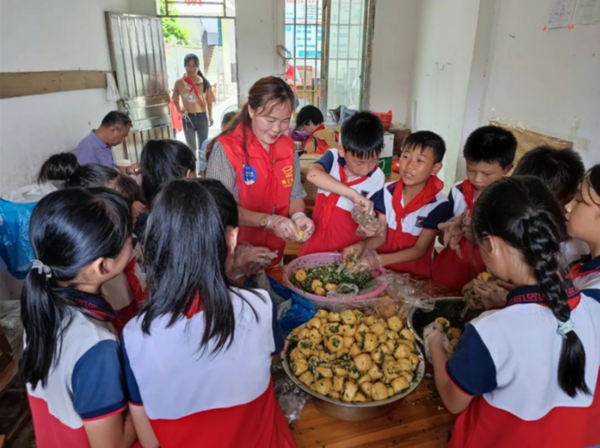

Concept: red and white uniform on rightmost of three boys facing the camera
[[431, 179, 486, 291]]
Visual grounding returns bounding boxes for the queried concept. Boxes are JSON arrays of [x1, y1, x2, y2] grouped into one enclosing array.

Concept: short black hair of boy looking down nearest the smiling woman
[[342, 112, 383, 159]]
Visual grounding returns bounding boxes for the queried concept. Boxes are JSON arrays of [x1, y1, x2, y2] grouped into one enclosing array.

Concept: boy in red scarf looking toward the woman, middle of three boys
[[344, 131, 449, 277]]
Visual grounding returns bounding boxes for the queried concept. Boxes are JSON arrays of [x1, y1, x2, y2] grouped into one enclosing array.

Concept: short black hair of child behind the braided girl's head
[[513, 146, 585, 202]]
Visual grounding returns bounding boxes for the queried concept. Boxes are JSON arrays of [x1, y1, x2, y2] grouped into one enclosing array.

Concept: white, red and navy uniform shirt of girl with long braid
[[446, 282, 600, 448]]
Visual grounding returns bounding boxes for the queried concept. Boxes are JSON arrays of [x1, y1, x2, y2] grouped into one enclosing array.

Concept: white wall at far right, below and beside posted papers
[[481, 0, 600, 166]]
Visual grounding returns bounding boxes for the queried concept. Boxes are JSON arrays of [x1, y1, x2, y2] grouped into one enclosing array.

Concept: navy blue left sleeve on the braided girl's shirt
[[446, 324, 498, 395]]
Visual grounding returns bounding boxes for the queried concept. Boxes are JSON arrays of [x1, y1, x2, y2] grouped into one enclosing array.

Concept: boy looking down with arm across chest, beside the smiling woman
[[298, 112, 385, 256]]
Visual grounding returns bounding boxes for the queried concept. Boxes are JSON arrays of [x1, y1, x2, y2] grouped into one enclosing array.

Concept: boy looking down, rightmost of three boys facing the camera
[[432, 126, 517, 291]]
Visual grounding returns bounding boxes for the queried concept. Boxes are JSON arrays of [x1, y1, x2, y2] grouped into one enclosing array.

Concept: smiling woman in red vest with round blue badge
[[206, 76, 314, 267]]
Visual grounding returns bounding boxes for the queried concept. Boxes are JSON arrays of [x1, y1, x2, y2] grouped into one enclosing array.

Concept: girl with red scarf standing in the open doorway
[[173, 54, 216, 158]]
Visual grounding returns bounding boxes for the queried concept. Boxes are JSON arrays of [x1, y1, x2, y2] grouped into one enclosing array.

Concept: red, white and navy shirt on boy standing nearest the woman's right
[[298, 149, 385, 256]]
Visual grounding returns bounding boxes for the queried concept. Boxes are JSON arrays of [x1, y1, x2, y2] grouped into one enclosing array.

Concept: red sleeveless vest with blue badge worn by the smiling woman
[[219, 124, 294, 269]]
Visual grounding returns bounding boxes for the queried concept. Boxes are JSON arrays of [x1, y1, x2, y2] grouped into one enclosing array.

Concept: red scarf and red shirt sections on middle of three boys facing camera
[[379, 176, 444, 278]]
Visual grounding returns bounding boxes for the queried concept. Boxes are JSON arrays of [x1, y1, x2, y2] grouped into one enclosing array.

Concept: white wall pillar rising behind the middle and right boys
[[409, 0, 479, 189]]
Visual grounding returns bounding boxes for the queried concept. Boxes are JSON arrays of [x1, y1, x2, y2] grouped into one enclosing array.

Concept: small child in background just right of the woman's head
[[296, 105, 340, 154]]
